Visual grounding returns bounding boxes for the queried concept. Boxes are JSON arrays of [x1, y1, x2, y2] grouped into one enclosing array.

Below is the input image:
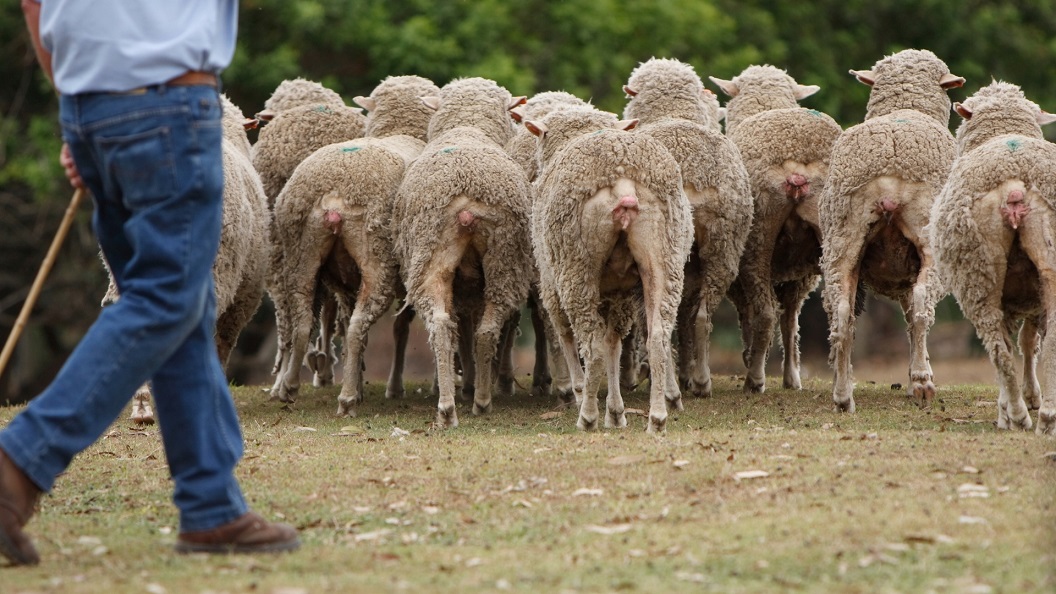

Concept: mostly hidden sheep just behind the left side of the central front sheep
[[506, 91, 590, 402]]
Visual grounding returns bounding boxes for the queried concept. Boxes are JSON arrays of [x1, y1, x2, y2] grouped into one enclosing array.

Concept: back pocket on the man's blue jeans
[[97, 127, 177, 210]]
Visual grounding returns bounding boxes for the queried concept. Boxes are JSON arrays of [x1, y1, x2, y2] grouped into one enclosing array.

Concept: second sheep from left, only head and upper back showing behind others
[[252, 81, 366, 204]]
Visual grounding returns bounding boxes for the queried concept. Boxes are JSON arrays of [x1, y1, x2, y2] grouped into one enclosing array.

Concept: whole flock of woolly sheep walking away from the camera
[[113, 50, 1056, 435]]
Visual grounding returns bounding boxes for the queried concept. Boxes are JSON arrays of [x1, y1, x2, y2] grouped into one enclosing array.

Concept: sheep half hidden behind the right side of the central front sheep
[[623, 58, 753, 396]]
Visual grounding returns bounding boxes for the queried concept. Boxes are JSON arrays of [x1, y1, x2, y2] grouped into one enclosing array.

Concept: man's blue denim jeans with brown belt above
[[0, 86, 246, 532]]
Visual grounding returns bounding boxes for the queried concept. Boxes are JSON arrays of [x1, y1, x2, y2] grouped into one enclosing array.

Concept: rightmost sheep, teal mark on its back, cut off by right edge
[[931, 81, 1056, 435]]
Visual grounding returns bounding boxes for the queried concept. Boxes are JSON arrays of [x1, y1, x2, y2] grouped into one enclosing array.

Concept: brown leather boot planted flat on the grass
[[176, 512, 301, 553]]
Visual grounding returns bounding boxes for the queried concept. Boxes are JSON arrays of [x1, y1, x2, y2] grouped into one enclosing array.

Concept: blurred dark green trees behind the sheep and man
[[0, 0, 1056, 403]]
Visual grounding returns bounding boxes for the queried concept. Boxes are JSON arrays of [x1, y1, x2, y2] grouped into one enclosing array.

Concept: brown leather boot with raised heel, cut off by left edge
[[0, 449, 41, 565]]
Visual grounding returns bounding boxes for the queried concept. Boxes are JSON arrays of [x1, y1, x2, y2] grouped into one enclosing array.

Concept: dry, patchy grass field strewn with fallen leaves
[[0, 367, 1056, 594]]
